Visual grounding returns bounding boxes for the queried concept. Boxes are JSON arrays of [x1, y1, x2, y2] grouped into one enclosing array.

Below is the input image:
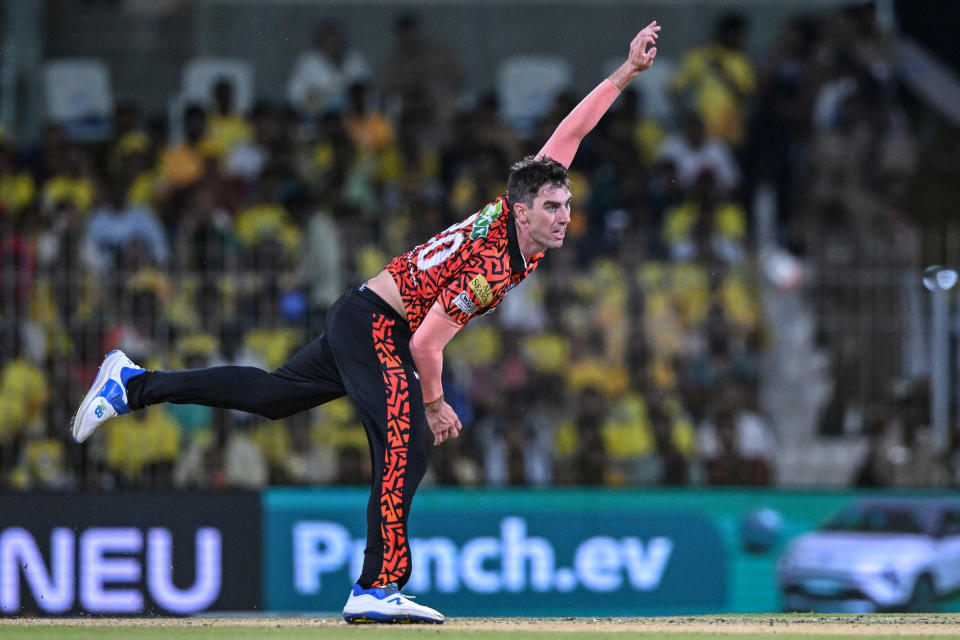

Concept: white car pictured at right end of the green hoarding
[[777, 498, 960, 612]]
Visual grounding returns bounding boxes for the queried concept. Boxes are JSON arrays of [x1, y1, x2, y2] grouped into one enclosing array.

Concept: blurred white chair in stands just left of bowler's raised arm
[[497, 55, 572, 130]]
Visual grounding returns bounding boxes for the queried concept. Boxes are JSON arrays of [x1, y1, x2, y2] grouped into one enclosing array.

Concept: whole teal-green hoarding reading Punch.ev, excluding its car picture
[[263, 489, 960, 616]]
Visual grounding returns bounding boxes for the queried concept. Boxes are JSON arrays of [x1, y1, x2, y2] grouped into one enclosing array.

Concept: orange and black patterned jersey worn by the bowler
[[387, 196, 543, 331]]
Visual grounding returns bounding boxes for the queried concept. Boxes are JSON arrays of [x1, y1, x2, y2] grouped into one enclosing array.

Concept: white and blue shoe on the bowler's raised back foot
[[73, 349, 144, 442]]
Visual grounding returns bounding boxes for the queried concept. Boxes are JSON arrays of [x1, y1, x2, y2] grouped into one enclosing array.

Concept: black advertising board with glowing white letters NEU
[[0, 492, 261, 615]]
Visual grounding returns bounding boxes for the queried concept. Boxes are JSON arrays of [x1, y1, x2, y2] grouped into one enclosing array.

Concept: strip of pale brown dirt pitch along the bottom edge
[[0, 615, 960, 637]]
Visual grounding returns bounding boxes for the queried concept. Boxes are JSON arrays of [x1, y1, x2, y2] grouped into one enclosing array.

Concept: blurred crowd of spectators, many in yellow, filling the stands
[[0, 8, 949, 489]]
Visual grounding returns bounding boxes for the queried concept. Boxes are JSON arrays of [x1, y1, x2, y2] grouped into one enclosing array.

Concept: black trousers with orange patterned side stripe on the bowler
[[127, 287, 432, 588]]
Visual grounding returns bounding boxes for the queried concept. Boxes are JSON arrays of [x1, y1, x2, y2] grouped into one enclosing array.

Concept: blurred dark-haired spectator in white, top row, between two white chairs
[[287, 20, 371, 116]]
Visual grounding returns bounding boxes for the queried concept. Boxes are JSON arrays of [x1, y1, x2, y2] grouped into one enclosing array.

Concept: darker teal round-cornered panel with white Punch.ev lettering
[[264, 490, 728, 615]]
